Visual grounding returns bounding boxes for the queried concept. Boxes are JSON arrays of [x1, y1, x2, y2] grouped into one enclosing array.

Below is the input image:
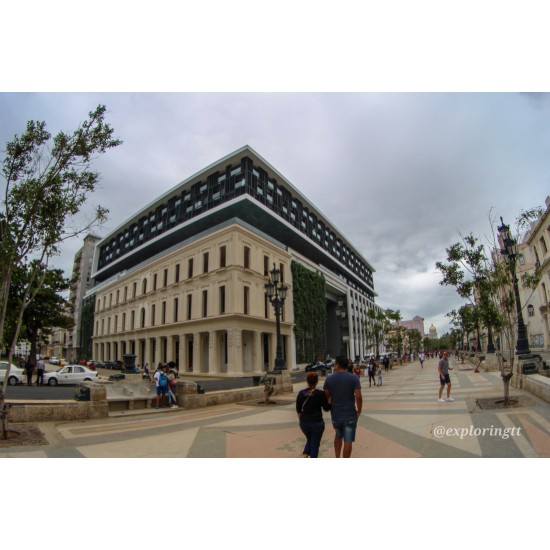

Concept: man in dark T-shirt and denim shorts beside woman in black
[[323, 356, 363, 458]]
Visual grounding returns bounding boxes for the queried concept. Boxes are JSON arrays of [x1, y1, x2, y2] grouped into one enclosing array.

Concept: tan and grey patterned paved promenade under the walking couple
[[0, 359, 550, 458]]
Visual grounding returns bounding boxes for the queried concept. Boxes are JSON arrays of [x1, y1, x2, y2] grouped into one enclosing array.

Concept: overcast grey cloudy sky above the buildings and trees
[[0, 93, 550, 334]]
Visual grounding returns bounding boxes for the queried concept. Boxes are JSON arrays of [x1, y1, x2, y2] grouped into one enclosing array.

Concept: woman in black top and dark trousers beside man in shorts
[[296, 372, 330, 458]]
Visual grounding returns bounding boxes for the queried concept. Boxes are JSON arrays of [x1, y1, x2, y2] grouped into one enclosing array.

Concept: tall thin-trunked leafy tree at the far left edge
[[0, 105, 122, 435]]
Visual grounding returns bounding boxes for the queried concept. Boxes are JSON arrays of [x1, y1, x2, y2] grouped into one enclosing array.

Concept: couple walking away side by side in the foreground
[[296, 357, 363, 458]]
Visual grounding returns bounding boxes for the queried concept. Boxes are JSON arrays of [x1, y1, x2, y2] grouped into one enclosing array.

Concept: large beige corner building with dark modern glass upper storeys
[[87, 146, 376, 376]]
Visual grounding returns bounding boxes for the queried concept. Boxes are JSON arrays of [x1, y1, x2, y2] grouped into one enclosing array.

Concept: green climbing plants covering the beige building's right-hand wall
[[291, 261, 327, 363]]
